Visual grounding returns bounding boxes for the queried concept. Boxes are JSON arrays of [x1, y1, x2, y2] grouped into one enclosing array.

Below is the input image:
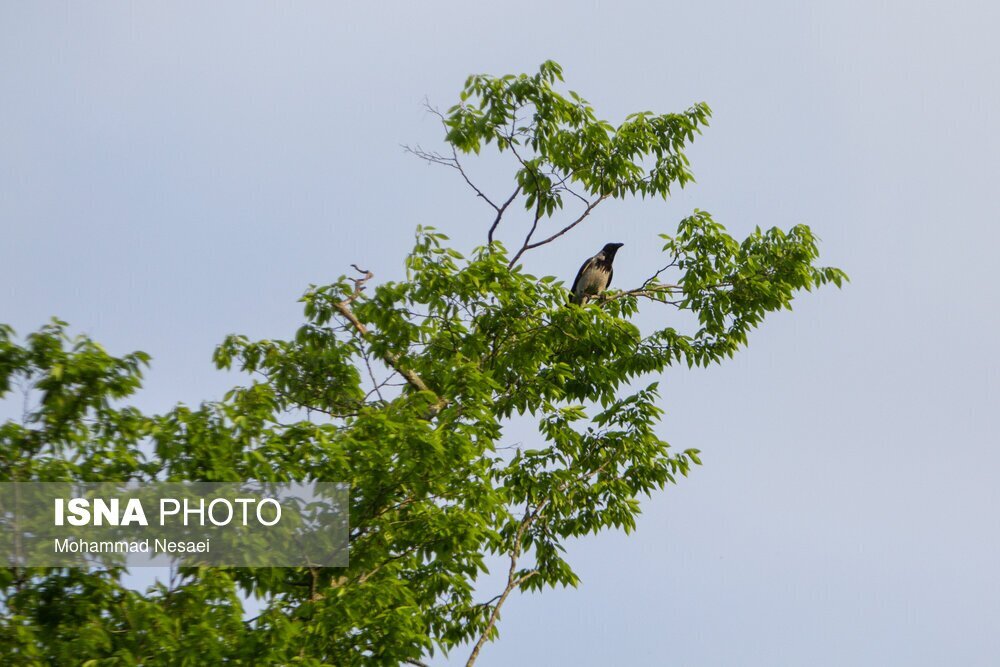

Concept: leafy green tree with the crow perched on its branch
[[0, 61, 845, 665]]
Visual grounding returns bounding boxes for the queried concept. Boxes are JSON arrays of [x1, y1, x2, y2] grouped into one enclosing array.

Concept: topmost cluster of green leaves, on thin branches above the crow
[[444, 60, 712, 209]]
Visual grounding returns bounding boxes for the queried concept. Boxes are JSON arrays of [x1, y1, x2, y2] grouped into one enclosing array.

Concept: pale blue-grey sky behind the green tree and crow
[[0, 0, 1000, 667]]
